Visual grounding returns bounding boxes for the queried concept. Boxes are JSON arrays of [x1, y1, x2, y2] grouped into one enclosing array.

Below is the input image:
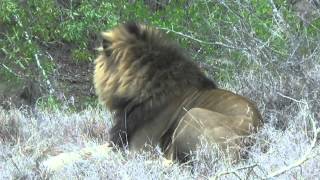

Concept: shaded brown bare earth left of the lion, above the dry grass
[[0, 39, 98, 109]]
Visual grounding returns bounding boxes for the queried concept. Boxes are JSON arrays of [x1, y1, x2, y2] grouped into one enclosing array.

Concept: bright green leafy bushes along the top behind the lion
[[0, 0, 320, 107]]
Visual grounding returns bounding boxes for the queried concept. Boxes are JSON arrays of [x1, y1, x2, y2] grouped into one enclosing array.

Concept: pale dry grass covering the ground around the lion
[[0, 59, 320, 179]]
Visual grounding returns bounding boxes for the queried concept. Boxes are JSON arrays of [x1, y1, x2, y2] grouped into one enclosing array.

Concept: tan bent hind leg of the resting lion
[[166, 108, 250, 162]]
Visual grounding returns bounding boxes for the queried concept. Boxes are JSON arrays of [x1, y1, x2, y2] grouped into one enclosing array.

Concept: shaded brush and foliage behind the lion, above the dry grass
[[0, 0, 319, 109]]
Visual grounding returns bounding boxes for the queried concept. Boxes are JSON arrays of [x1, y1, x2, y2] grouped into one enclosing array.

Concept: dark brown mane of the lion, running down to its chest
[[96, 22, 216, 145]]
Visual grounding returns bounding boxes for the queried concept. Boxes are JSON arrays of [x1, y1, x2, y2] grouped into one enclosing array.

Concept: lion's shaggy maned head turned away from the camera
[[94, 23, 215, 109]]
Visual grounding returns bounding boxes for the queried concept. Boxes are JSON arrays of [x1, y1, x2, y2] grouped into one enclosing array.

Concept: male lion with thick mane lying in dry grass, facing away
[[94, 23, 262, 162]]
